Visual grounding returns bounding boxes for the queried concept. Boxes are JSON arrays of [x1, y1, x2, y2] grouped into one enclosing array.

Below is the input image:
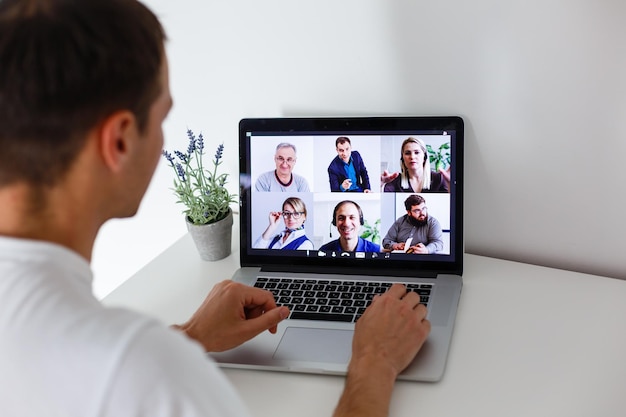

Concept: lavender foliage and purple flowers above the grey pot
[[163, 129, 237, 224]]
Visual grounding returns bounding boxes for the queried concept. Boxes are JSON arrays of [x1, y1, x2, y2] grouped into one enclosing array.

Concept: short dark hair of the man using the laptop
[[0, 0, 166, 186]]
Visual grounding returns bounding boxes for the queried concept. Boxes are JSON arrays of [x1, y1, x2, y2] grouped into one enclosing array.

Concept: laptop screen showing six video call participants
[[239, 117, 463, 276]]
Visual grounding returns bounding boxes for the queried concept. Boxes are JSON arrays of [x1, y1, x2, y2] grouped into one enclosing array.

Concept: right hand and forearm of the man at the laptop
[[334, 284, 431, 417]]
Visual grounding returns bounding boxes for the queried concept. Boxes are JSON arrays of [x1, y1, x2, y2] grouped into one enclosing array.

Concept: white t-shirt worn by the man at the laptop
[[0, 237, 254, 417]]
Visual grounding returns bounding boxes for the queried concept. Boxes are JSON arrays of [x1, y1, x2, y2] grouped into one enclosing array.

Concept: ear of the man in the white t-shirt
[[98, 110, 137, 172]]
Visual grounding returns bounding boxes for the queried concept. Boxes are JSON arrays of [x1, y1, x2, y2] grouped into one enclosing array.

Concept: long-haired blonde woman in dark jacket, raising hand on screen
[[380, 137, 450, 193]]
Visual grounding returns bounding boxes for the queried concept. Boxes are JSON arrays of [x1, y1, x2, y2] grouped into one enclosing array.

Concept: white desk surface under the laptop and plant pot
[[104, 230, 626, 417]]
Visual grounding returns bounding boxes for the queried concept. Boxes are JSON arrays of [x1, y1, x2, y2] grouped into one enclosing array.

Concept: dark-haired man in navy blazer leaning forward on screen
[[328, 136, 371, 193]]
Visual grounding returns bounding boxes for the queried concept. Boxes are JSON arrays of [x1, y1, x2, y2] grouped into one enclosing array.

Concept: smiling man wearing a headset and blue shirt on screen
[[320, 200, 380, 252]]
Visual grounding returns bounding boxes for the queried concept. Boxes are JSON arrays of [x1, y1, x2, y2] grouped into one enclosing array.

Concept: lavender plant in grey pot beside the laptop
[[163, 129, 237, 261]]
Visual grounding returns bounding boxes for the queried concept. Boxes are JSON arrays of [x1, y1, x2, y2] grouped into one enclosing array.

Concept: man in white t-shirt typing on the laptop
[[0, 0, 430, 417]]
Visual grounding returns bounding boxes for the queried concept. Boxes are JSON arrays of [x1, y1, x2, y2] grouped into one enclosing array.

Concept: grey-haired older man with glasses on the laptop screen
[[254, 143, 309, 193]]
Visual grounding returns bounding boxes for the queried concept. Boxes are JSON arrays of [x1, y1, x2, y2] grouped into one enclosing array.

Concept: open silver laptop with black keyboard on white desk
[[211, 116, 464, 381]]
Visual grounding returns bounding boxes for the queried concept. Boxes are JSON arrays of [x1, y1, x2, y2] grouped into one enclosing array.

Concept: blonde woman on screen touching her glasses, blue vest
[[252, 197, 313, 250]]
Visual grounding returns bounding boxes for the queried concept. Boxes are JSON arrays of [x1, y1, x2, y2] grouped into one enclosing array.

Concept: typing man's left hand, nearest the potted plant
[[174, 280, 289, 352]]
